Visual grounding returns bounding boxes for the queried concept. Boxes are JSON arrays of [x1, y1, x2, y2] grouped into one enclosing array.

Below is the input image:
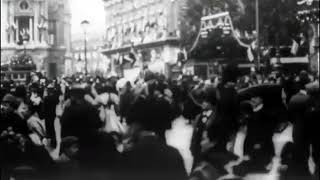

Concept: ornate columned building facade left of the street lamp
[[1, 0, 71, 78]]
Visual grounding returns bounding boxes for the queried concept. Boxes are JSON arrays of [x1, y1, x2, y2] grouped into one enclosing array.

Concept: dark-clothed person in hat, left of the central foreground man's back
[[56, 86, 120, 180]]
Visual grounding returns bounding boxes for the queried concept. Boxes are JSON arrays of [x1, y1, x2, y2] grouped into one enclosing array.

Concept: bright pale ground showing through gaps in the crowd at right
[[166, 117, 313, 180]]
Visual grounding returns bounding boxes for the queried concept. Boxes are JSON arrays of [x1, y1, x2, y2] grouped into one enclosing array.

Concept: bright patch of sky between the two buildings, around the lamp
[[70, 0, 105, 39]]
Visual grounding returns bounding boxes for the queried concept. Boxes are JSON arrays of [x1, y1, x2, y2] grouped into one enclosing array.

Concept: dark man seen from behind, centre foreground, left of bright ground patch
[[119, 99, 187, 180]]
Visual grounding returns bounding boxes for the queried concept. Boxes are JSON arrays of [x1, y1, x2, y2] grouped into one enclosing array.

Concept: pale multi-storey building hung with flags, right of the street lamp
[[102, 0, 184, 75]]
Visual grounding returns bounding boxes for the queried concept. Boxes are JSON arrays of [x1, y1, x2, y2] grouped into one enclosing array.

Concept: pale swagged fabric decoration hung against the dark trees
[[188, 12, 251, 52]]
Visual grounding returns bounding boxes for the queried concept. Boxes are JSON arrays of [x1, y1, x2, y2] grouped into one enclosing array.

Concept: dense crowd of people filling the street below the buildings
[[0, 65, 320, 180]]
